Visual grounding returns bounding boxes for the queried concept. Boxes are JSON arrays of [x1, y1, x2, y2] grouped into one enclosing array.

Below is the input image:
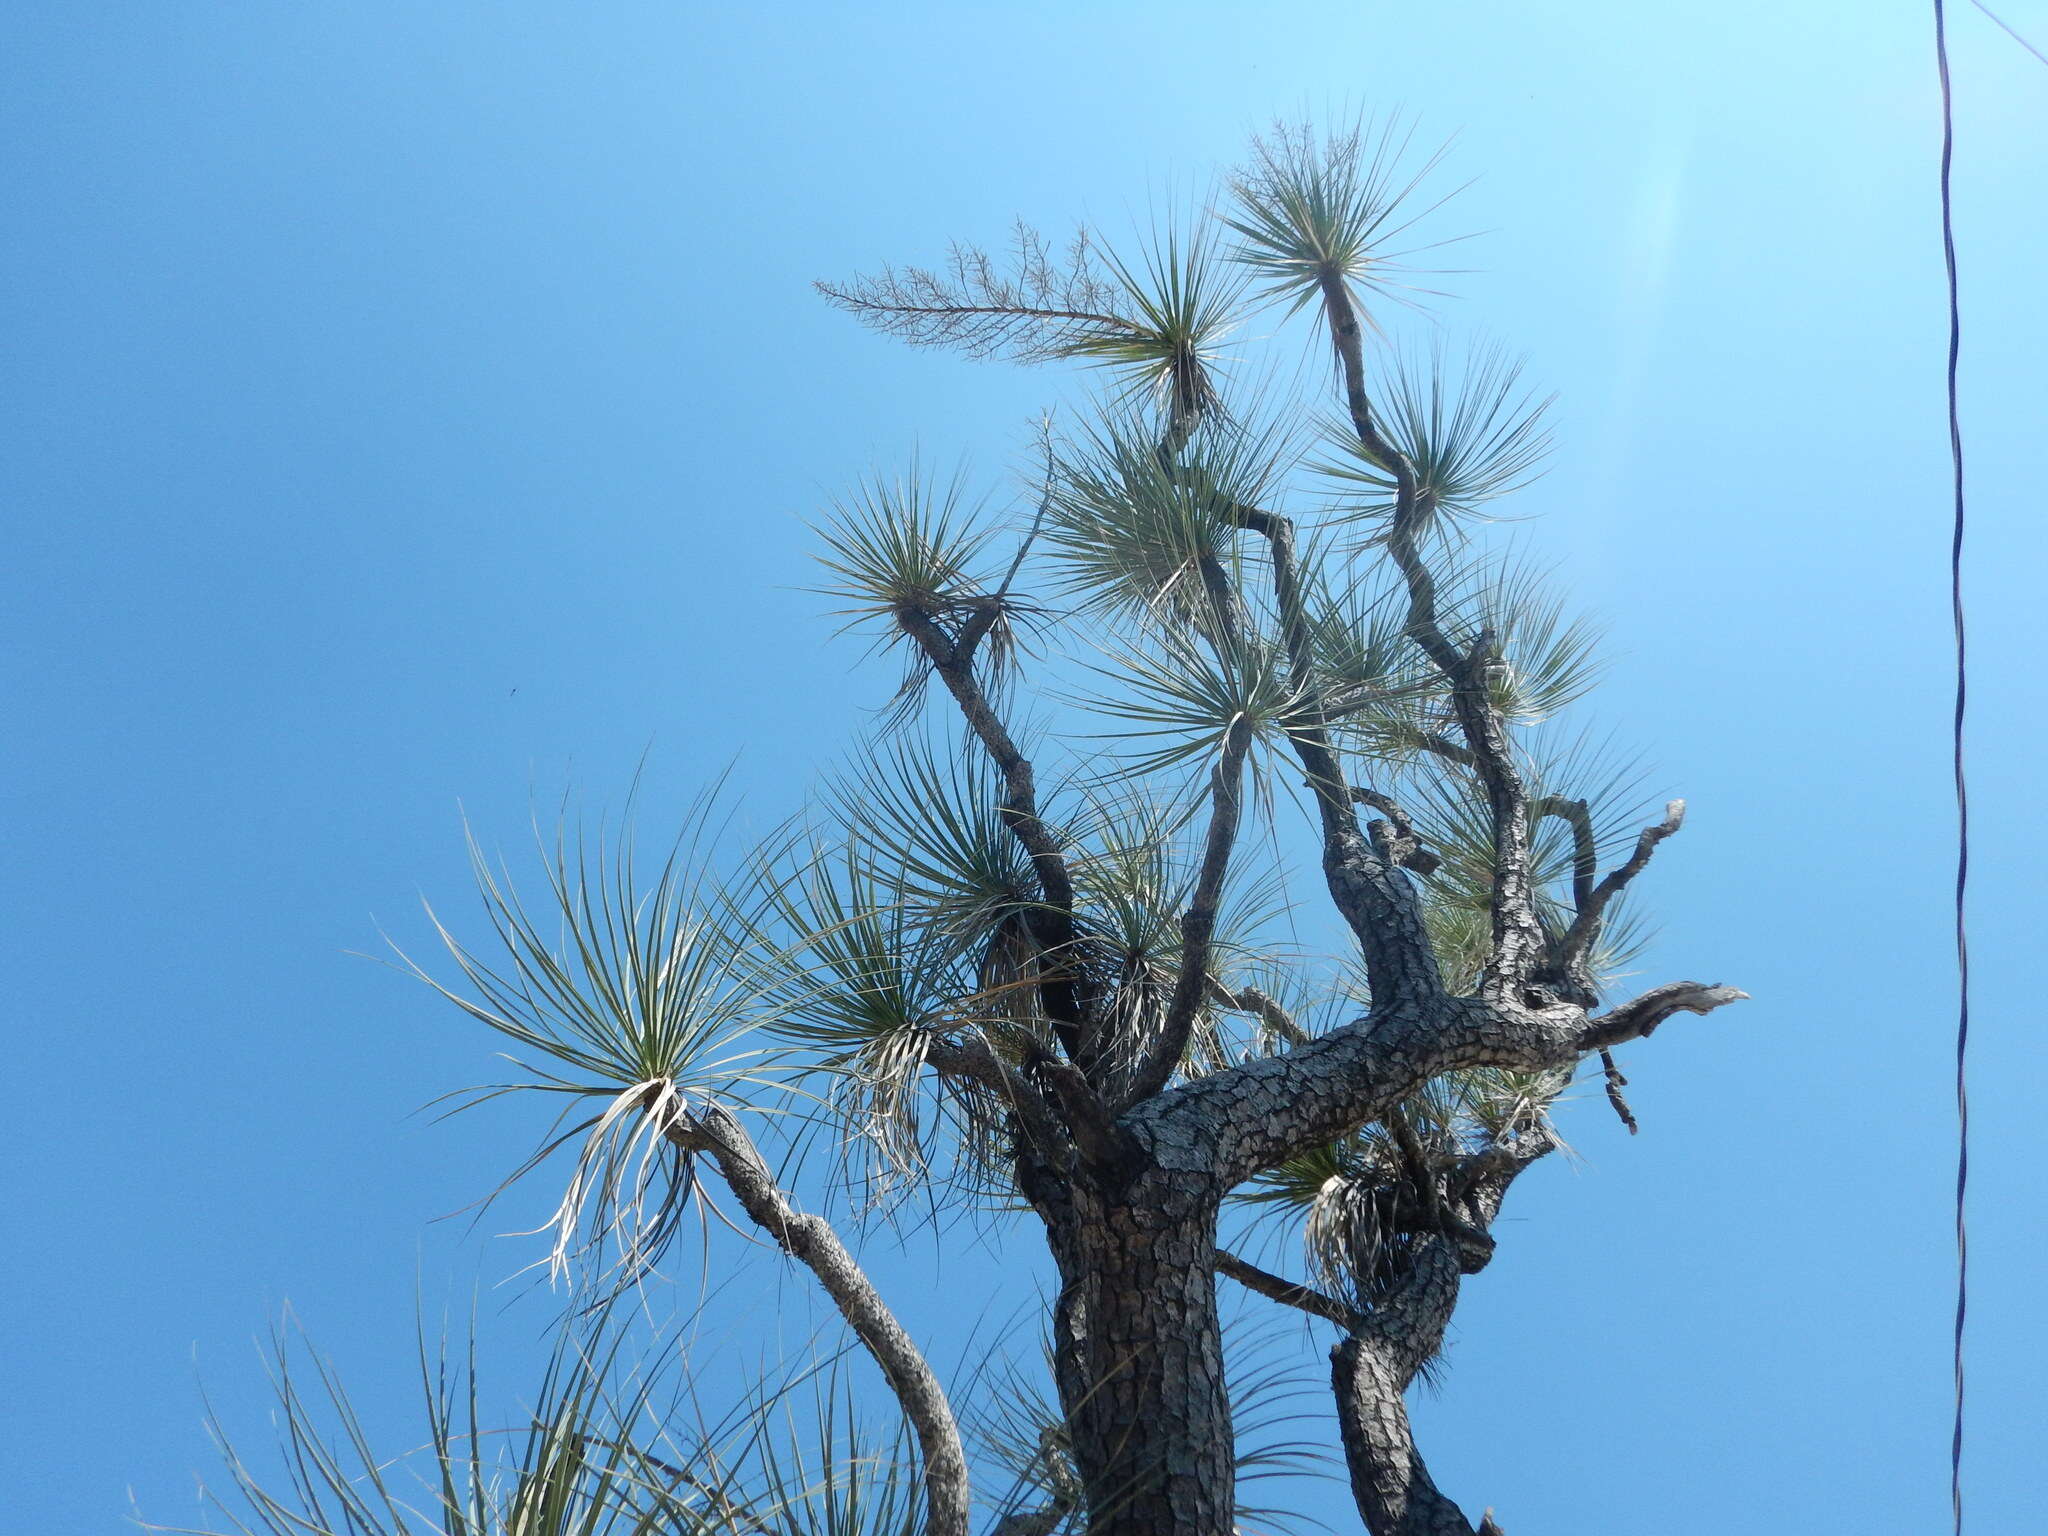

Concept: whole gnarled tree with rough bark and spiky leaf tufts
[[172, 127, 1743, 1536]]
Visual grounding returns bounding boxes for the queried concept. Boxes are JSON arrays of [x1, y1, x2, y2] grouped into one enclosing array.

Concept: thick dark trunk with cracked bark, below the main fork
[[1040, 1167, 1235, 1536]]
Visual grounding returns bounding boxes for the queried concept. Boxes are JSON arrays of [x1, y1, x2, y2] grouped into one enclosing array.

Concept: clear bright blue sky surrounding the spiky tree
[[0, 0, 2048, 1536]]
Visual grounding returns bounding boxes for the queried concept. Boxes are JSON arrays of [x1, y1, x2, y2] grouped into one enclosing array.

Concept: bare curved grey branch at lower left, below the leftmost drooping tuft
[[664, 1104, 969, 1536]]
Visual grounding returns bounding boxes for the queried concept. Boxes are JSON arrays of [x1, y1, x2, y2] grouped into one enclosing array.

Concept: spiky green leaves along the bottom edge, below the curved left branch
[[157, 1313, 920, 1536]]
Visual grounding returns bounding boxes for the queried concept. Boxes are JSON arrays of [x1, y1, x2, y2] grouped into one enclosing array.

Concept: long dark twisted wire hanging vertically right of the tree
[[1933, 0, 1970, 1536]]
